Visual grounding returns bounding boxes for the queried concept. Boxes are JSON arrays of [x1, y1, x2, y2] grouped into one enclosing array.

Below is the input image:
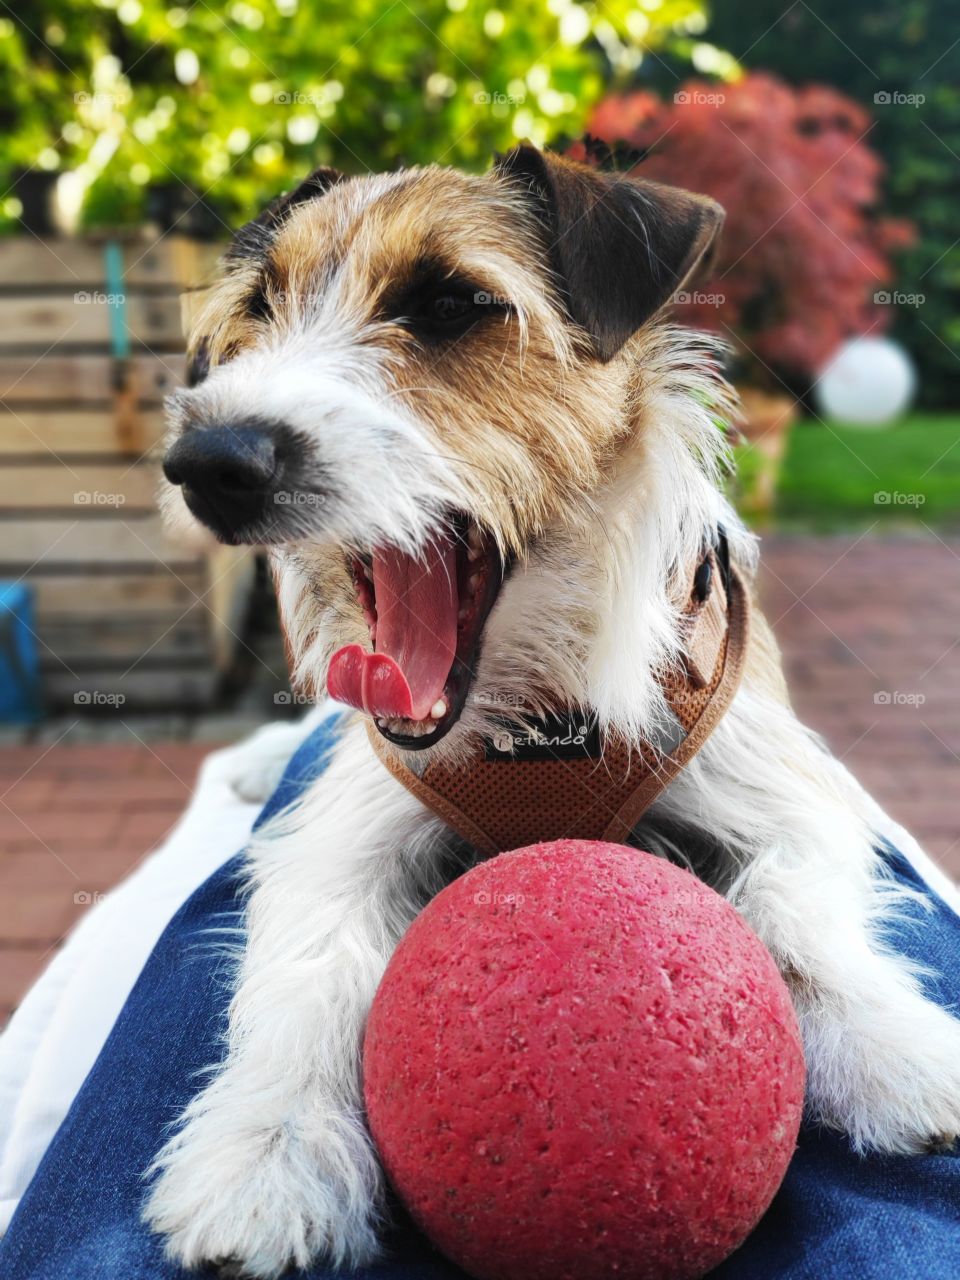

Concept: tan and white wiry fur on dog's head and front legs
[[146, 154, 960, 1276]]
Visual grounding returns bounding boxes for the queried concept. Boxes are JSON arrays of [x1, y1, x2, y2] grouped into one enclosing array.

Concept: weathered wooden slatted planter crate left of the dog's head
[[0, 236, 252, 712]]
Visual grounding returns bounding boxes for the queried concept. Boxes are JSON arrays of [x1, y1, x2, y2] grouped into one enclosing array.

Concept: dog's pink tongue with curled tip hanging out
[[326, 536, 458, 719]]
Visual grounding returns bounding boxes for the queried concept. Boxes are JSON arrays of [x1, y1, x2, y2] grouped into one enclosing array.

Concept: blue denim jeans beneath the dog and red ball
[[0, 722, 960, 1280]]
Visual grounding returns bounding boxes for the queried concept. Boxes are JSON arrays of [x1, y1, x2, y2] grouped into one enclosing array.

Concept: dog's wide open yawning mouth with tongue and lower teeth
[[326, 516, 506, 750]]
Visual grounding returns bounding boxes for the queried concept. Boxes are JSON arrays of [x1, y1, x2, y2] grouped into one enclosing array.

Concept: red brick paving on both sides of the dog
[[0, 536, 960, 1020]]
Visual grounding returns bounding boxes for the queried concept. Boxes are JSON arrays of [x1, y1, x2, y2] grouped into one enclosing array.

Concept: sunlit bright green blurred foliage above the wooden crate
[[0, 0, 704, 232]]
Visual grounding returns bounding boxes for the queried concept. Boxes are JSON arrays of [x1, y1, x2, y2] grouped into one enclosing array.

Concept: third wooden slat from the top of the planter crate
[[0, 353, 186, 408]]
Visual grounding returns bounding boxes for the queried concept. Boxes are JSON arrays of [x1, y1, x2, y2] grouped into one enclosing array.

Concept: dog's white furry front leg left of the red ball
[[147, 723, 471, 1276]]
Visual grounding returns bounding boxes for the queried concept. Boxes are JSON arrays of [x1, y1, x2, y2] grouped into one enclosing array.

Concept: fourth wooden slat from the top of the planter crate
[[0, 410, 164, 458]]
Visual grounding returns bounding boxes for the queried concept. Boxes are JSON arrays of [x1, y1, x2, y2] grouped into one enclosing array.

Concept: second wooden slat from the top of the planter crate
[[0, 289, 183, 351]]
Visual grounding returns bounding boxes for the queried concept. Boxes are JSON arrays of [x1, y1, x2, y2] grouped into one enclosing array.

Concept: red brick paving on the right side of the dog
[[762, 536, 960, 878]]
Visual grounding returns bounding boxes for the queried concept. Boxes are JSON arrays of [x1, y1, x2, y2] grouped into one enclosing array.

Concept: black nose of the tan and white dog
[[164, 425, 280, 541]]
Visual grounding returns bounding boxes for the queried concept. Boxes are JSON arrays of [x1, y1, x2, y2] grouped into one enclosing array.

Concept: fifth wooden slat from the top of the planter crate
[[0, 457, 160, 518]]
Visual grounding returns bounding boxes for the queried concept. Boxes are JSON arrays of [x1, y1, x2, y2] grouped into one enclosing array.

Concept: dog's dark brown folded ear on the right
[[494, 142, 723, 362]]
